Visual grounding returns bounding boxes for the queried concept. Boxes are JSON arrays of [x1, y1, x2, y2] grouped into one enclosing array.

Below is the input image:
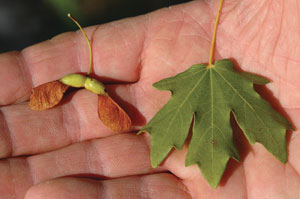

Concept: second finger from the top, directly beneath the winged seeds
[[0, 90, 136, 158]]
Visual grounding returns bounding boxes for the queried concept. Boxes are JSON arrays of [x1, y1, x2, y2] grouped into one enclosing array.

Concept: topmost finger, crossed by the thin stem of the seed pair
[[0, 13, 146, 106]]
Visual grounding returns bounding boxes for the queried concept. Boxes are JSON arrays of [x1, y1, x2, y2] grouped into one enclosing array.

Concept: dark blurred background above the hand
[[0, 0, 189, 53]]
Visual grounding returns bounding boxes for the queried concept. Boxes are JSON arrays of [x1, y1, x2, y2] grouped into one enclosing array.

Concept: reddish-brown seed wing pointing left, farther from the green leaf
[[29, 81, 69, 110]]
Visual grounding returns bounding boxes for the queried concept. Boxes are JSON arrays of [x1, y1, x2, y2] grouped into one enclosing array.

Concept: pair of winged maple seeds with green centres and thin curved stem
[[29, 14, 131, 132]]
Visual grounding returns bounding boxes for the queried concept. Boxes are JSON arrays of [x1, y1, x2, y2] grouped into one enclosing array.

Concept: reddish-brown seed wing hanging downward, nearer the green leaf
[[98, 95, 131, 132]]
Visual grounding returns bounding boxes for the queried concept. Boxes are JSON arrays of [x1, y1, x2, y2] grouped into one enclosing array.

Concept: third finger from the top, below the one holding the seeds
[[0, 134, 163, 198]]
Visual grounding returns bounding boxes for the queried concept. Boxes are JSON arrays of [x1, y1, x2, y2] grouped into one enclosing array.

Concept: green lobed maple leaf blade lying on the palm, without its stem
[[139, 59, 292, 188]]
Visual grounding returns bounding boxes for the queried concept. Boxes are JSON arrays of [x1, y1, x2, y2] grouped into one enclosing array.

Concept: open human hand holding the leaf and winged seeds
[[0, 0, 300, 199]]
